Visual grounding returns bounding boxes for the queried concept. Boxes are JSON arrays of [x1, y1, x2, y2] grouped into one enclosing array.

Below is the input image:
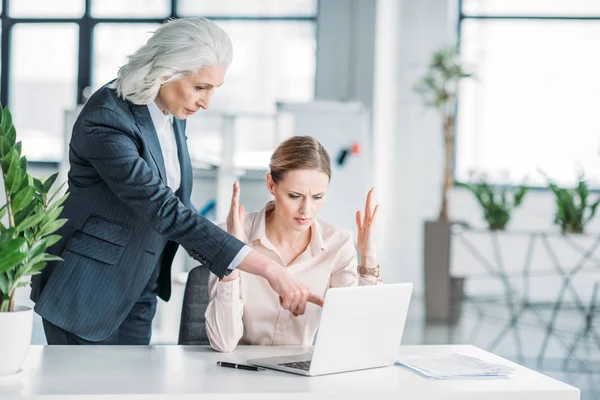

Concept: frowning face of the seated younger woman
[[267, 169, 329, 232]]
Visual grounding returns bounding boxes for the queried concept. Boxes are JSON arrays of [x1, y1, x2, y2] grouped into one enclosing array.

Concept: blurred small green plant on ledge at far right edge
[[546, 171, 600, 233]]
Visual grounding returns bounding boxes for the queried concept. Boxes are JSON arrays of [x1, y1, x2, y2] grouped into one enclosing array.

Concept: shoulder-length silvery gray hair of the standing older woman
[[110, 18, 233, 105]]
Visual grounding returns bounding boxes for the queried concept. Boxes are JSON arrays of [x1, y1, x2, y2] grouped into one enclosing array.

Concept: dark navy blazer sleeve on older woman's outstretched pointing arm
[[71, 107, 244, 278]]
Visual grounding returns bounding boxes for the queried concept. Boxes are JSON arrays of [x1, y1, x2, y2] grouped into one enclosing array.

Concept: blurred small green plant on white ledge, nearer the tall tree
[[456, 175, 527, 231]]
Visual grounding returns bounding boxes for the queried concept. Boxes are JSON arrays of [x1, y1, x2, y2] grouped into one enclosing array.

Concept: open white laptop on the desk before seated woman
[[248, 283, 413, 376]]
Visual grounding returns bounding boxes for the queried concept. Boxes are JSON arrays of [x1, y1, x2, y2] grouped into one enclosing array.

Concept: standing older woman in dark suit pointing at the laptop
[[31, 18, 323, 345]]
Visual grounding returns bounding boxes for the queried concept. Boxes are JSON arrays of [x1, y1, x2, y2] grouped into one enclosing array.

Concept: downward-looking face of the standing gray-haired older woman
[[155, 65, 227, 119]]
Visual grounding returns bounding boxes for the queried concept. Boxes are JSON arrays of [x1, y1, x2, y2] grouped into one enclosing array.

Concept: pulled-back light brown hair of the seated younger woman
[[269, 136, 331, 184]]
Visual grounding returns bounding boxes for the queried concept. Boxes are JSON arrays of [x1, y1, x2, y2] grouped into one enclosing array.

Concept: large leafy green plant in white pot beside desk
[[0, 106, 68, 377]]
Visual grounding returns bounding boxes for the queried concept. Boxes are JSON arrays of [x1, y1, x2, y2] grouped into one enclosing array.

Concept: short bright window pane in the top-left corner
[[8, 0, 85, 18]]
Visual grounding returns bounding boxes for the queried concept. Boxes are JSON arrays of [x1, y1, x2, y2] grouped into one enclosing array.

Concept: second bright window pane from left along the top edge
[[92, 0, 171, 18]]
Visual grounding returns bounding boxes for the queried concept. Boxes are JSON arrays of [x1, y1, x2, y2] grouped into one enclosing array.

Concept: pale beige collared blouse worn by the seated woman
[[206, 202, 378, 352]]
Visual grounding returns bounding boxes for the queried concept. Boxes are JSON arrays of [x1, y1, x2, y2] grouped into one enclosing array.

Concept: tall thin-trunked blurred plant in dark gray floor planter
[[414, 44, 471, 323]]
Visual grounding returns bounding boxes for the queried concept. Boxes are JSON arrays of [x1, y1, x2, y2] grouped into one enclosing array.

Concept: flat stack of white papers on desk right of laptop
[[396, 353, 514, 379]]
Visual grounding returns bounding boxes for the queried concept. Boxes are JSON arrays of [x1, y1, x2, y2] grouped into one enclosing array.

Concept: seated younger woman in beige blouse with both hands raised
[[206, 136, 381, 352]]
